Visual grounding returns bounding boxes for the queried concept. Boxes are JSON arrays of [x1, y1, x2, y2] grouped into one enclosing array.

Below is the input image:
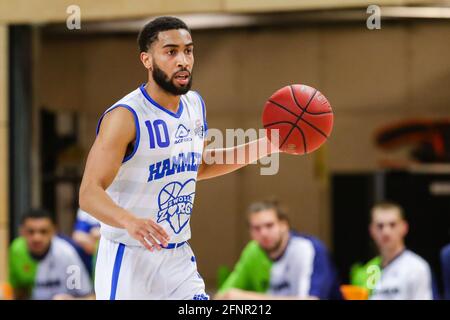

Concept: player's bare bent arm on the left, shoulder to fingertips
[[80, 108, 169, 251]]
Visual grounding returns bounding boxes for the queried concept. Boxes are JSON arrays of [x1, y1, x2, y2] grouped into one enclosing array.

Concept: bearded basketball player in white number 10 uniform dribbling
[[80, 17, 278, 299]]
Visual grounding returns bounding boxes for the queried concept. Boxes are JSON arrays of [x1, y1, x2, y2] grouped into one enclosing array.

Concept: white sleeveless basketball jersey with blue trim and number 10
[[97, 85, 207, 246]]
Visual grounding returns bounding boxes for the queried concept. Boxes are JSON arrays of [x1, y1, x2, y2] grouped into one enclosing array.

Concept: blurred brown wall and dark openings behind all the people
[[0, 0, 450, 296]]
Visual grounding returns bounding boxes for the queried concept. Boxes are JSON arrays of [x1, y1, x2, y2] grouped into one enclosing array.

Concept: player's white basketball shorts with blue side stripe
[[95, 237, 209, 300]]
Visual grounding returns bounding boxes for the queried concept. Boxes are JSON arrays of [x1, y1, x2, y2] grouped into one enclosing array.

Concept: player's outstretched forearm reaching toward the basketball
[[197, 137, 274, 180]]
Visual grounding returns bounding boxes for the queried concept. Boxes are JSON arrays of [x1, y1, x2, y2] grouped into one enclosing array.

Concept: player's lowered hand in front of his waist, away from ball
[[124, 217, 170, 251]]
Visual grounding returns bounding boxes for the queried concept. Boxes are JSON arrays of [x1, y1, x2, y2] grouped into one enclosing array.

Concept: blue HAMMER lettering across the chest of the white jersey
[[147, 152, 202, 182]]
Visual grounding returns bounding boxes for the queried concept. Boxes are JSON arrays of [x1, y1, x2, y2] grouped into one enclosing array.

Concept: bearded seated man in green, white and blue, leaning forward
[[216, 201, 341, 300]]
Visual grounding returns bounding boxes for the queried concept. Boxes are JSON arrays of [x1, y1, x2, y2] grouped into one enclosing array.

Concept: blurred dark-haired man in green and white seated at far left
[[9, 210, 93, 300]]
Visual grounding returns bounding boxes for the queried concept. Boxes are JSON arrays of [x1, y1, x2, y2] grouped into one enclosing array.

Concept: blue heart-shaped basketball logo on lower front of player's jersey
[[157, 179, 195, 234]]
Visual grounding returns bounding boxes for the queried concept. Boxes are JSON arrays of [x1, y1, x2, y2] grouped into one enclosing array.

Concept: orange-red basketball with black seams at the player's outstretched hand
[[262, 84, 333, 154]]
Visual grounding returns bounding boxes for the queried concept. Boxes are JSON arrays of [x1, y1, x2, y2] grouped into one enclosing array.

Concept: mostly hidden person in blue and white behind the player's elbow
[[72, 209, 100, 274]]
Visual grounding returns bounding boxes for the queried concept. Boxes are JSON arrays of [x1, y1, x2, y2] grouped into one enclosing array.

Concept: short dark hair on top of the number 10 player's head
[[138, 16, 191, 52]]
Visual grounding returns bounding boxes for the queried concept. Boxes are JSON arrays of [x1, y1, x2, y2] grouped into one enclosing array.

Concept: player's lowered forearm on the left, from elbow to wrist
[[79, 183, 134, 228]]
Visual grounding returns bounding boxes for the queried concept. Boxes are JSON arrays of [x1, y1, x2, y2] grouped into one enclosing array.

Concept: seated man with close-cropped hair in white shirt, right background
[[367, 202, 433, 300]]
